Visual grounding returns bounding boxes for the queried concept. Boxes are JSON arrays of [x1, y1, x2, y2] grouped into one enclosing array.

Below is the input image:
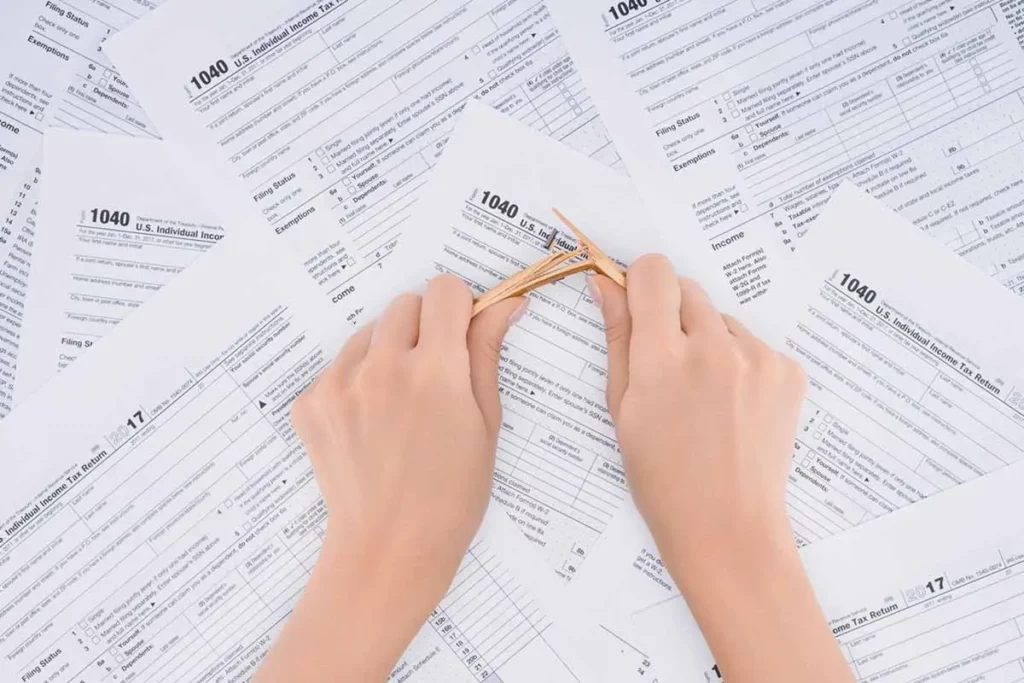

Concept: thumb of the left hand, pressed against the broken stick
[[466, 297, 527, 434]]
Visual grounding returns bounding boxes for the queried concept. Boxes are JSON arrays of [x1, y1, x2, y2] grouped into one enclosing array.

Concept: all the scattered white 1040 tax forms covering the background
[[0, 0, 1024, 683]]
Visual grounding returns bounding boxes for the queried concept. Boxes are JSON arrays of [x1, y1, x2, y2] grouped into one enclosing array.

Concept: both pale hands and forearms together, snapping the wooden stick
[[254, 255, 854, 683]]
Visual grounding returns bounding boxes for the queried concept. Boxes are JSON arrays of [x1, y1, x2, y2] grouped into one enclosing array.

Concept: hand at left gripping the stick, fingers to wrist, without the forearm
[[292, 275, 525, 618]]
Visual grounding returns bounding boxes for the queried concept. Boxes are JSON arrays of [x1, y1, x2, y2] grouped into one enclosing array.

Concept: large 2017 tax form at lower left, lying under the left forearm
[[0, 229, 621, 683]]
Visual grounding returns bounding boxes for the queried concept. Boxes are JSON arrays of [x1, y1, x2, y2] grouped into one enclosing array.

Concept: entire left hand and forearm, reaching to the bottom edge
[[257, 275, 525, 683]]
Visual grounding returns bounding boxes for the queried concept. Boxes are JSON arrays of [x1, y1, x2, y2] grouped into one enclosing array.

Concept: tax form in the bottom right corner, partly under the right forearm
[[580, 411, 1024, 683]]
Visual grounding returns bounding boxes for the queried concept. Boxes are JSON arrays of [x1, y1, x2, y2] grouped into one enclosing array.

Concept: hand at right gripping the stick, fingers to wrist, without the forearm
[[590, 255, 806, 593]]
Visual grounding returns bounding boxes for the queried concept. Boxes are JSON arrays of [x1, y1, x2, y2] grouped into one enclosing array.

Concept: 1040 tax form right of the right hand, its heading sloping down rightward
[[571, 184, 1024, 680]]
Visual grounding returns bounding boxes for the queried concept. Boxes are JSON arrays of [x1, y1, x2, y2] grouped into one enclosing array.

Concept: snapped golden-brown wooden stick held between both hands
[[473, 209, 626, 315]]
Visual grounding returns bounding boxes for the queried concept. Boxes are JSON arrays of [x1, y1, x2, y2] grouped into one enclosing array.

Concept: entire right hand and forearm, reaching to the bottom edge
[[591, 256, 853, 683]]
